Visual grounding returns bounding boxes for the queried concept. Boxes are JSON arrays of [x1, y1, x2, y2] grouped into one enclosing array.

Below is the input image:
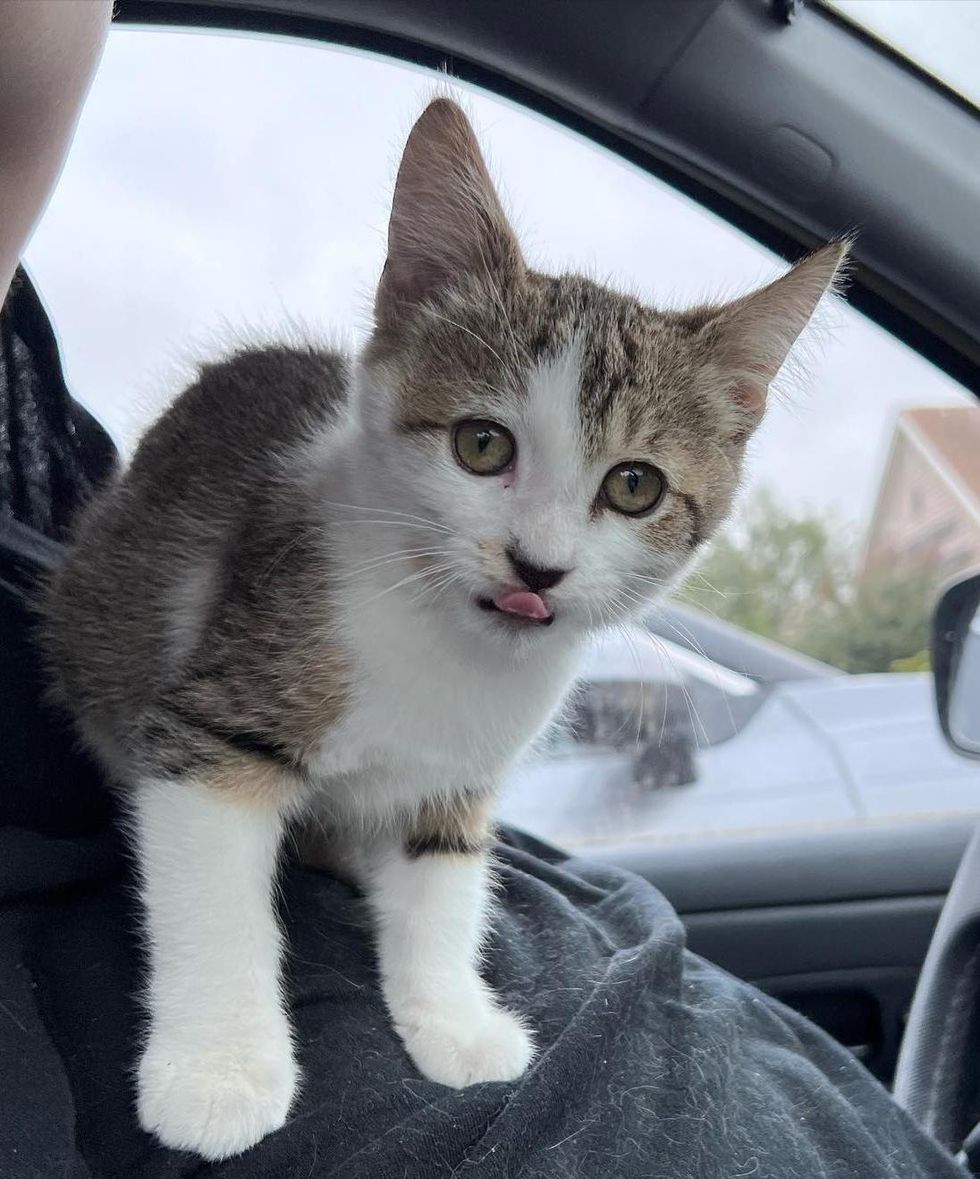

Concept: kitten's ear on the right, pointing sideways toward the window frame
[[709, 242, 850, 430]]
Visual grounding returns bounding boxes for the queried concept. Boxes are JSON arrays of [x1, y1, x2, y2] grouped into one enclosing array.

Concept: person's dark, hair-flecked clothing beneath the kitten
[[0, 269, 962, 1179]]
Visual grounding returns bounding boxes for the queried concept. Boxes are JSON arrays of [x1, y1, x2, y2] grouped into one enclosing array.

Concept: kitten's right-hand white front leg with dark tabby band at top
[[368, 798, 534, 1088]]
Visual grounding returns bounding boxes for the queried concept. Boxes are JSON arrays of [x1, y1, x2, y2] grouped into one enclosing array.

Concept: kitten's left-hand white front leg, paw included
[[134, 782, 298, 1159]]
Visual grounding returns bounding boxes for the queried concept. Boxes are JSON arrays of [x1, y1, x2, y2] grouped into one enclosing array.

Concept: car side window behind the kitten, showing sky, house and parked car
[[27, 29, 980, 847]]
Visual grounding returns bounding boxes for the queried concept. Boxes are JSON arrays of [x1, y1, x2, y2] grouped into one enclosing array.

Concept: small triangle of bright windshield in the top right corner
[[824, 0, 980, 106]]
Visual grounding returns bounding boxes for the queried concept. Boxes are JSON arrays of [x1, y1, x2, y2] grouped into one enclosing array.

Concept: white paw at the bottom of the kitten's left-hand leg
[[137, 1034, 300, 1160]]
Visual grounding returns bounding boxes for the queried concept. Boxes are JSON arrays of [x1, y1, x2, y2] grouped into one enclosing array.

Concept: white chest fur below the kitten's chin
[[318, 584, 579, 818]]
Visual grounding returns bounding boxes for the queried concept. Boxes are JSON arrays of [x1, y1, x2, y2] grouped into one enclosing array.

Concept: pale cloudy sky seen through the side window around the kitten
[[27, 22, 962, 533]]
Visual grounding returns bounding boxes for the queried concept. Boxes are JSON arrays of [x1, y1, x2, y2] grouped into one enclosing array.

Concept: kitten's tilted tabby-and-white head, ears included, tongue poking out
[[357, 99, 846, 635]]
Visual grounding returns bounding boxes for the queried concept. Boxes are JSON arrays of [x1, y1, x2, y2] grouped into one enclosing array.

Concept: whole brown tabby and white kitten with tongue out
[[45, 99, 844, 1159]]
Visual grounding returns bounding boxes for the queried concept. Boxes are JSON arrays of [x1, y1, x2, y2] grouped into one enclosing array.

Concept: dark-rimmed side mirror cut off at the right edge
[[933, 573, 980, 758]]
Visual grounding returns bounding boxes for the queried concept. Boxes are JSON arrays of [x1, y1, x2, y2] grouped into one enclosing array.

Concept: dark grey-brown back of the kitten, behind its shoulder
[[42, 347, 349, 760]]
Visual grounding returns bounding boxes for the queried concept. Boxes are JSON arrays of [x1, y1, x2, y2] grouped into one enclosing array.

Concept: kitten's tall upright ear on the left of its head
[[375, 98, 524, 324]]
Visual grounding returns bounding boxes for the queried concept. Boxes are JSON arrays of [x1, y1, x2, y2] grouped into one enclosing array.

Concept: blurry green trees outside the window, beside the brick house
[[679, 492, 935, 672]]
